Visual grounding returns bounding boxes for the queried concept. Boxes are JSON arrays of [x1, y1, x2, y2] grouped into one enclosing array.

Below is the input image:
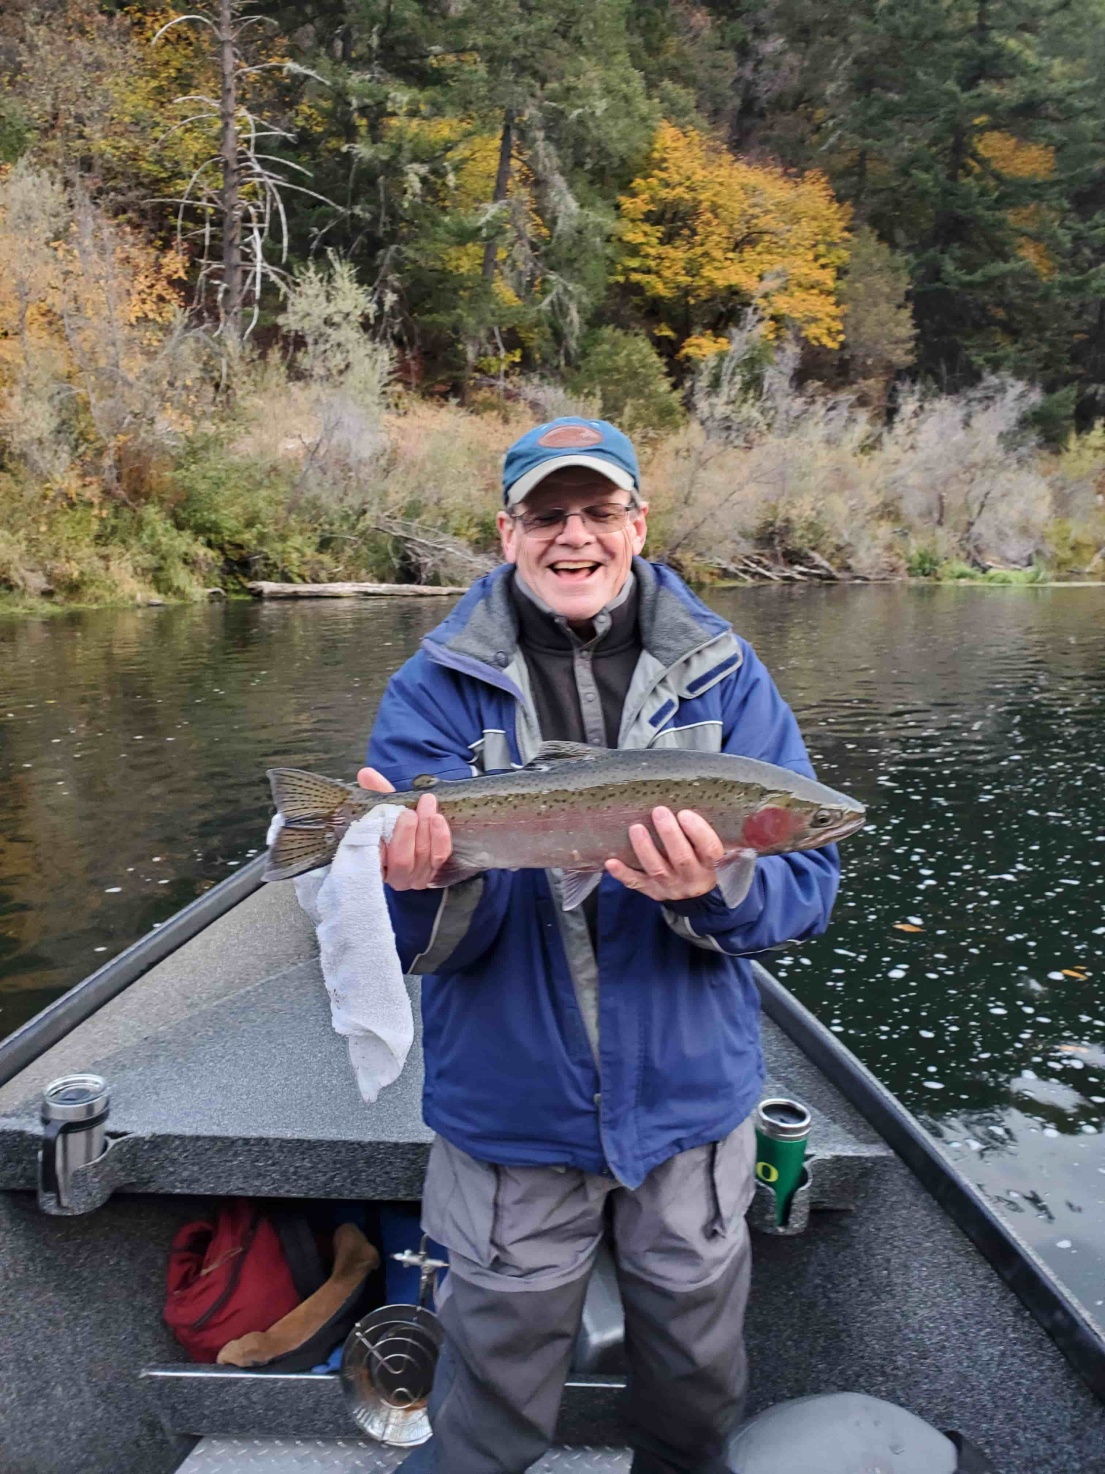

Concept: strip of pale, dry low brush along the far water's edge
[[0, 363, 1105, 615]]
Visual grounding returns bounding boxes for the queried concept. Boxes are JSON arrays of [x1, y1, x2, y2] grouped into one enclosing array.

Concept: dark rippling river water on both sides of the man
[[0, 585, 1105, 1316]]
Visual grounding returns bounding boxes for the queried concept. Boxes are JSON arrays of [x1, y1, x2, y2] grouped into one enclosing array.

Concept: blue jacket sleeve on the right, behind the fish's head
[[664, 640, 840, 957]]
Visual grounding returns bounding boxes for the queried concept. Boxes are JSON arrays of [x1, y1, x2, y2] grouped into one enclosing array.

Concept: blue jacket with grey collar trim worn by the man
[[368, 559, 838, 1188]]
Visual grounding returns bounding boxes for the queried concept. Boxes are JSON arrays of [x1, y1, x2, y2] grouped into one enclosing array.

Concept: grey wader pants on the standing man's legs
[[404, 1122, 754, 1474]]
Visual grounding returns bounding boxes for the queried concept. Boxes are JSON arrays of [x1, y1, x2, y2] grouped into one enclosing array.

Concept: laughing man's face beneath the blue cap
[[498, 466, 648, 624]]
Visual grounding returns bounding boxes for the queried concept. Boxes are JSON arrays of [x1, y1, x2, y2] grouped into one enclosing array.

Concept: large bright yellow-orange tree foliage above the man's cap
[[614, 122, 849, 358]]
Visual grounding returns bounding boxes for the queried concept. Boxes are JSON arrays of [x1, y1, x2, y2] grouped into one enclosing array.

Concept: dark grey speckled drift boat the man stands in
[[0, 856, 1105, 1474]]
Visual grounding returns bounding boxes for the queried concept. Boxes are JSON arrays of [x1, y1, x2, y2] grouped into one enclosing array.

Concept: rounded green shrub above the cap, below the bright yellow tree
[[567, 327, 687, 441]]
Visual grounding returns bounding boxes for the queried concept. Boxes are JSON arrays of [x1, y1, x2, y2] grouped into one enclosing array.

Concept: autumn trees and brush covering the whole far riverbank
[[0, 0, 1105, 613]]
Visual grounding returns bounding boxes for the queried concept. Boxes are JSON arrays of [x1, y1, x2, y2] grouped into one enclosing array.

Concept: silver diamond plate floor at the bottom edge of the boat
[[177, 1439, 629, 1474]]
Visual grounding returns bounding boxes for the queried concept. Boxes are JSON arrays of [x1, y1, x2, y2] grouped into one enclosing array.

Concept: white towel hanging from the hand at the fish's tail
[[267, 803, 414, 1104]]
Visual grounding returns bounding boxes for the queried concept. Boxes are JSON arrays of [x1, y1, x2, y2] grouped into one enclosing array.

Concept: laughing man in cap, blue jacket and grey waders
[[358, 419, 838, 1474]]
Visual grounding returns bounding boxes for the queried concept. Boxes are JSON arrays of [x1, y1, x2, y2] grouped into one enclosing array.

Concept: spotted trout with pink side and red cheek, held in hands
[[264, 741, 866, 911]]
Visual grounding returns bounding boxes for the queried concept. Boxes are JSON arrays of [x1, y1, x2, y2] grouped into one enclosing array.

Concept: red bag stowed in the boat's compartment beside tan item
[[164, 1198, 302, 1362]]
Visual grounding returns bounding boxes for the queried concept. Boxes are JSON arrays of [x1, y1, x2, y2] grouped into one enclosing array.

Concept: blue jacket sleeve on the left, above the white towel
[[367, 653, 511, 973]]
